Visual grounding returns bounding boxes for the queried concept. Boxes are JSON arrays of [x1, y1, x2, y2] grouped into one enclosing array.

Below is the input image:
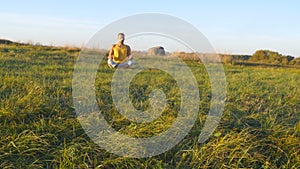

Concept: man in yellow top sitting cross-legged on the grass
[[107, 33, 134, 68]]
